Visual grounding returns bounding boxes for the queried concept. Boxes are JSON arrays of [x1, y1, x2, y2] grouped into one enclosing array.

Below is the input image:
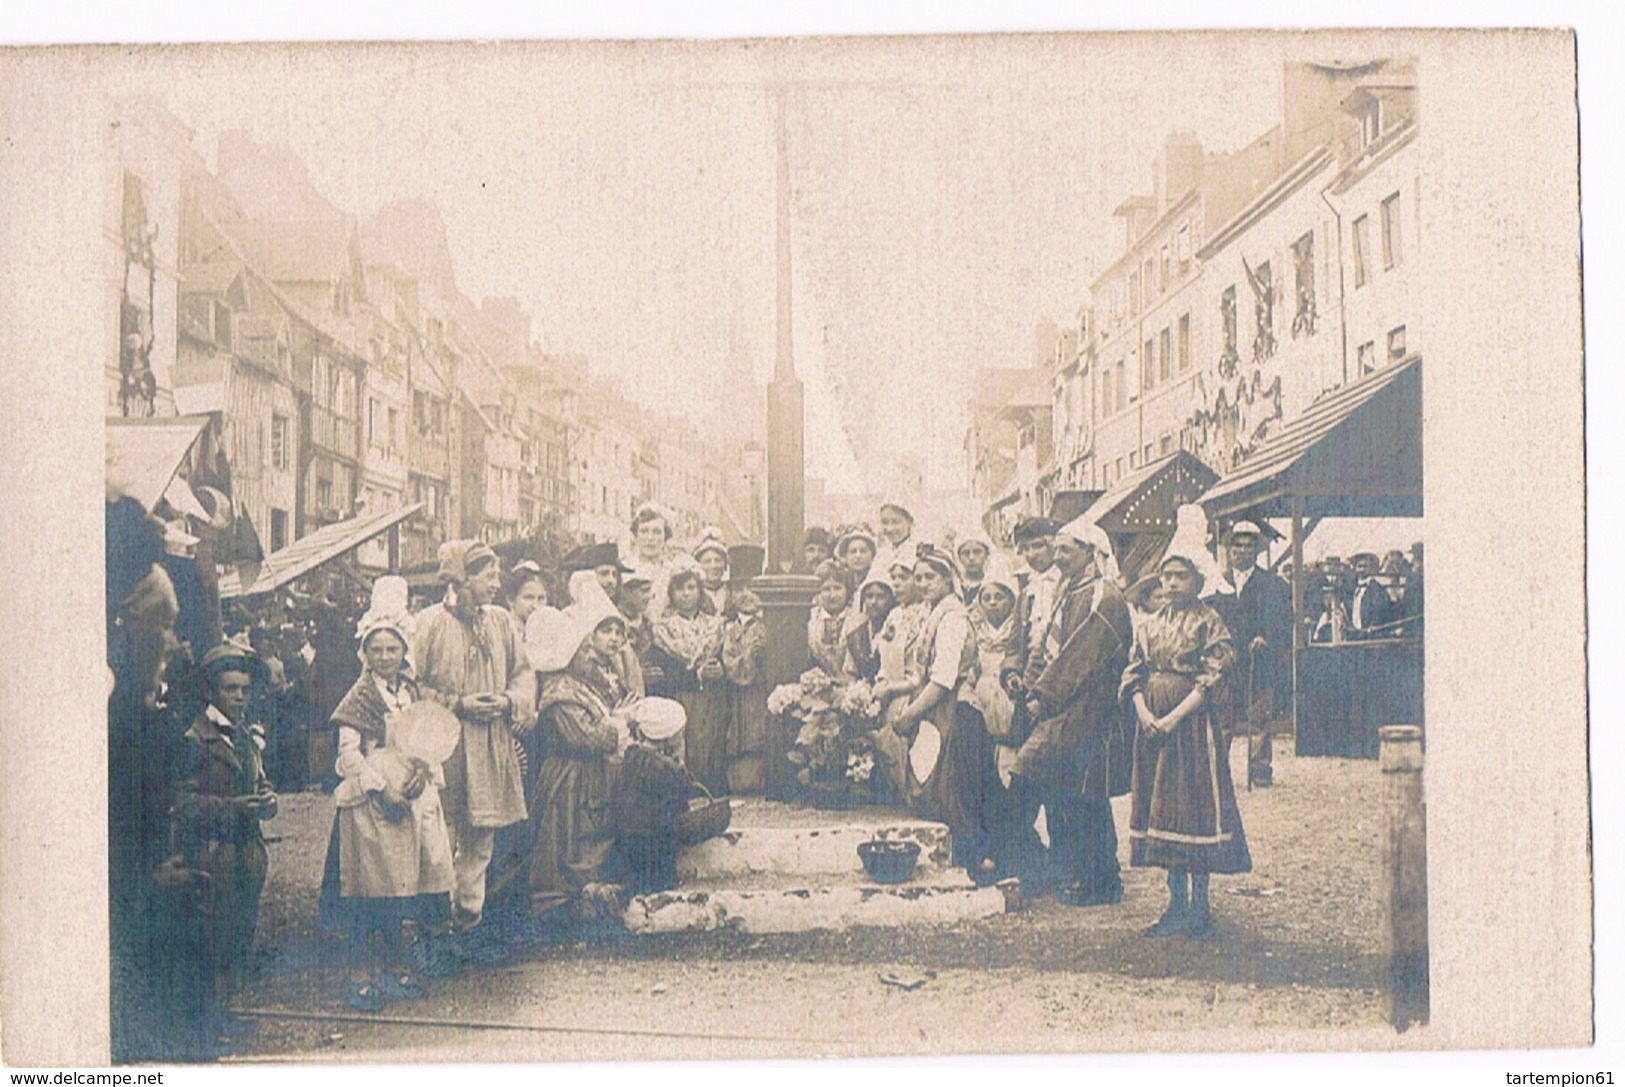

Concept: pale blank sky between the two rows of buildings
[[132, 36, 1287, 492]]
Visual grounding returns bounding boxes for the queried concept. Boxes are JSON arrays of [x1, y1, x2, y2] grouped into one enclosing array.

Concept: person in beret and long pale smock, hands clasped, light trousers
[[413, 539, 536, 929]]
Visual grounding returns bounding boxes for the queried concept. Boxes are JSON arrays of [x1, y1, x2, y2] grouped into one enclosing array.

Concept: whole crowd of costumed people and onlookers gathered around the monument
[[109, 487, 1420, 1059]]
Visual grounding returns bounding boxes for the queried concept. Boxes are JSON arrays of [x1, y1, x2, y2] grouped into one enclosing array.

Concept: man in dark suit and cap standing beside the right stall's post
[[1207, 522, 1292, 788]]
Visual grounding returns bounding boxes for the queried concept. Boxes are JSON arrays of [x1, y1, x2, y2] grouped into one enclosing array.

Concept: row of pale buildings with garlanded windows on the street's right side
[[967, 60, 1422, 531]]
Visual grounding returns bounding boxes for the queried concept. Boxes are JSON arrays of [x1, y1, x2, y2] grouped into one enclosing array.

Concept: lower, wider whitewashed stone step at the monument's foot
[[622, 868, 1006, 934]]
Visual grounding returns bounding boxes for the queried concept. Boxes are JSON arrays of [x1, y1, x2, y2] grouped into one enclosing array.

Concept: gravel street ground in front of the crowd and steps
[[229, 739, 1407, 1063]]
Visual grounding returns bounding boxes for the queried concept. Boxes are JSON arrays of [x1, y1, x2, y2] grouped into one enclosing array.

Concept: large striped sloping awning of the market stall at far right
[[1203, 356, 1422, 520]]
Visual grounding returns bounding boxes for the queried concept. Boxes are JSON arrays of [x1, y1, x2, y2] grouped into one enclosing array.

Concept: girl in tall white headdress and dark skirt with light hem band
[[1120, 538, 1253, 939]]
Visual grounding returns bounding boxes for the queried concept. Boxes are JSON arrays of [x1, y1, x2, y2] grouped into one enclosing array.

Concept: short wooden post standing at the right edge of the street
[[1378, 725, 1428, 1032]]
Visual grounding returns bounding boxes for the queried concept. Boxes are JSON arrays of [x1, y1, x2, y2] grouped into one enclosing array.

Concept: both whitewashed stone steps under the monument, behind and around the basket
[[624, 799, 1009, 934]]
